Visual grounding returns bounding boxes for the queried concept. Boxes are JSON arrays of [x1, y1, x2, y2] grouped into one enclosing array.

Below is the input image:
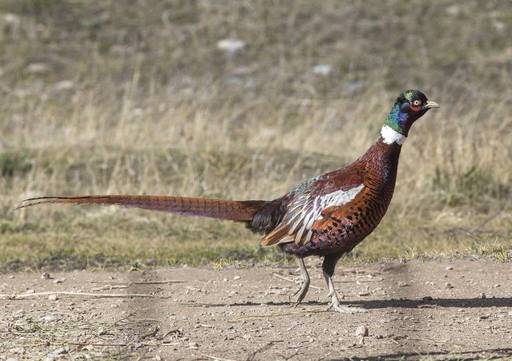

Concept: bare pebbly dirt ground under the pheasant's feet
[[0, 260, 512, 361]]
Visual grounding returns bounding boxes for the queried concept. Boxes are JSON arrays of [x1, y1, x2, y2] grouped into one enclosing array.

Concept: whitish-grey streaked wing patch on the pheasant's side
[[279, 184, 364, 243]]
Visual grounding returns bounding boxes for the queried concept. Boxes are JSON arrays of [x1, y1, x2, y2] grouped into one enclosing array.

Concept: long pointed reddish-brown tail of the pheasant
[[17, 195, 267, 222]]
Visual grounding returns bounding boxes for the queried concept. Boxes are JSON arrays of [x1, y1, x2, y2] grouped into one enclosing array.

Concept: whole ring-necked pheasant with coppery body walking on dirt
[[18, 90, 439, 313]]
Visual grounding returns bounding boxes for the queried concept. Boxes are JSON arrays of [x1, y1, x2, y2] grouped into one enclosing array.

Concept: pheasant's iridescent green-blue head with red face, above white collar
[[384, 90, 439, 136]]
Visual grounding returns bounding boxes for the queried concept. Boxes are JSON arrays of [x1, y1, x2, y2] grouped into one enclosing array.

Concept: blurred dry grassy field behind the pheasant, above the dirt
[[0, 0, 512, 271]]
